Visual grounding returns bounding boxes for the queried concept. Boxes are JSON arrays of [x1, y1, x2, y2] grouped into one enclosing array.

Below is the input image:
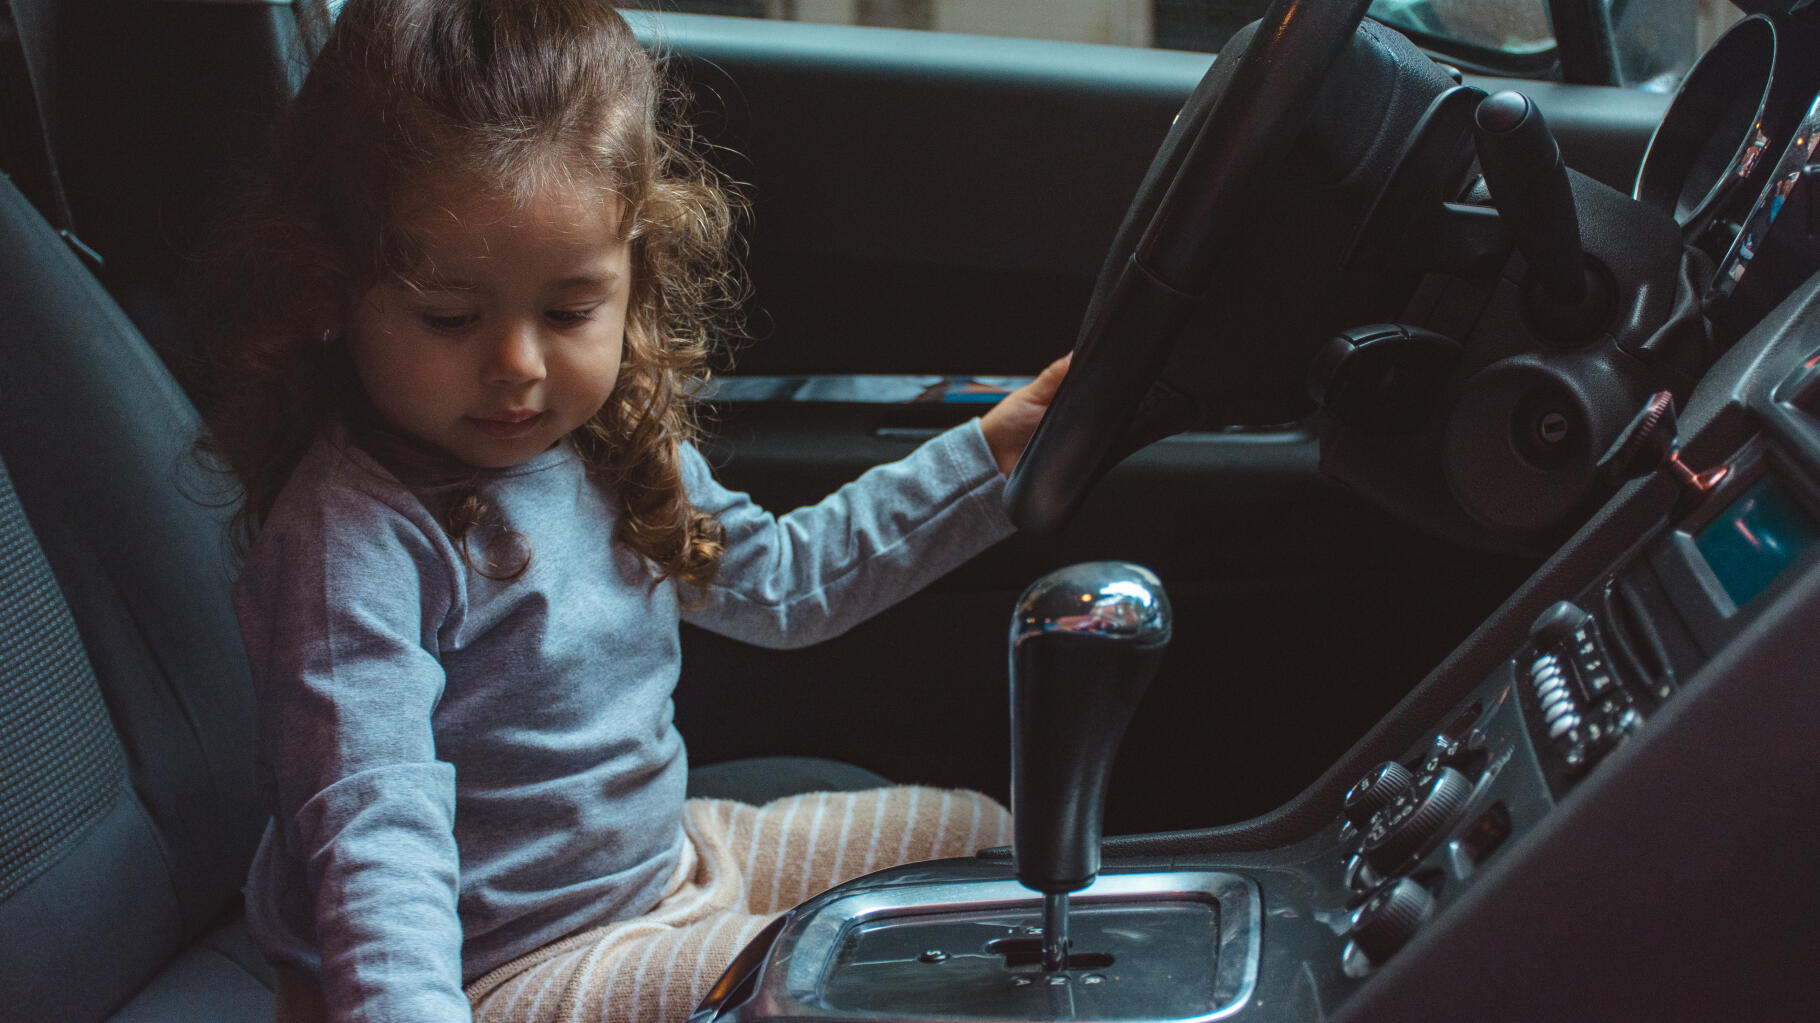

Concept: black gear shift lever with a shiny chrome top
[[1010, 561, 1170, 970]]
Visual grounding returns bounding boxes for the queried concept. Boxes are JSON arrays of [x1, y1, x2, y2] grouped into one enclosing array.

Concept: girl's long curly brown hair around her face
[[204, 0, 744, 586]]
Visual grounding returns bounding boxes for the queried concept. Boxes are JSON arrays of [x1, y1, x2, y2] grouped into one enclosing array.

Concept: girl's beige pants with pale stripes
[[468, 788, 1012, 1023]]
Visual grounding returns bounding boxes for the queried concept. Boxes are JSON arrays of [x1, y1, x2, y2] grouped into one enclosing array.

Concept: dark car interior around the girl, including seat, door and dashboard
[[0, 0, 1820, 1023]]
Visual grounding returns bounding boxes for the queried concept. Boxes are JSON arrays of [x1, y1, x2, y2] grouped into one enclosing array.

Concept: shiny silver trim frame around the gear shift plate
[[752, 870, 1263, 1023]]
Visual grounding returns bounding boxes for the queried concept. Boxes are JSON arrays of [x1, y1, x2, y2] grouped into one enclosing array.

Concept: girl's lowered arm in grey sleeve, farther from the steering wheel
[[237, 476, 470, 1019]]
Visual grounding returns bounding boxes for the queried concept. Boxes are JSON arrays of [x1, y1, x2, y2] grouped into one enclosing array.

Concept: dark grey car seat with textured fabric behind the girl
[[0, 171, 271, 1023]]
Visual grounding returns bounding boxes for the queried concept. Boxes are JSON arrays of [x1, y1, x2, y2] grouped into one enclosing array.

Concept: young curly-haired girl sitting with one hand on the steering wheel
[[209, 0, 1067, 1021]]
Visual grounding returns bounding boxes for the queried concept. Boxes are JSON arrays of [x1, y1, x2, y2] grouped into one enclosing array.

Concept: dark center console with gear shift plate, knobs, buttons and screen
[[693, 279, 1820, 1023]]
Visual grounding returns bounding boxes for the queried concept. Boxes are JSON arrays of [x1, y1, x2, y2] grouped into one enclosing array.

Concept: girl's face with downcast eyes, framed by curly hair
[[348, 187, 632, 468]]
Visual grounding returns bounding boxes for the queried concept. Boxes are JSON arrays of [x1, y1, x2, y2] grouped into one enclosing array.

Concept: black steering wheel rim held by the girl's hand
[[1005, 0, 1370, 535]]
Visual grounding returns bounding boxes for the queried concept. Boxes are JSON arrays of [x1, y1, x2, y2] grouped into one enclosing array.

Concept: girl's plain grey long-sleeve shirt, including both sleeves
[[235, 422, 1010, 1019]]
